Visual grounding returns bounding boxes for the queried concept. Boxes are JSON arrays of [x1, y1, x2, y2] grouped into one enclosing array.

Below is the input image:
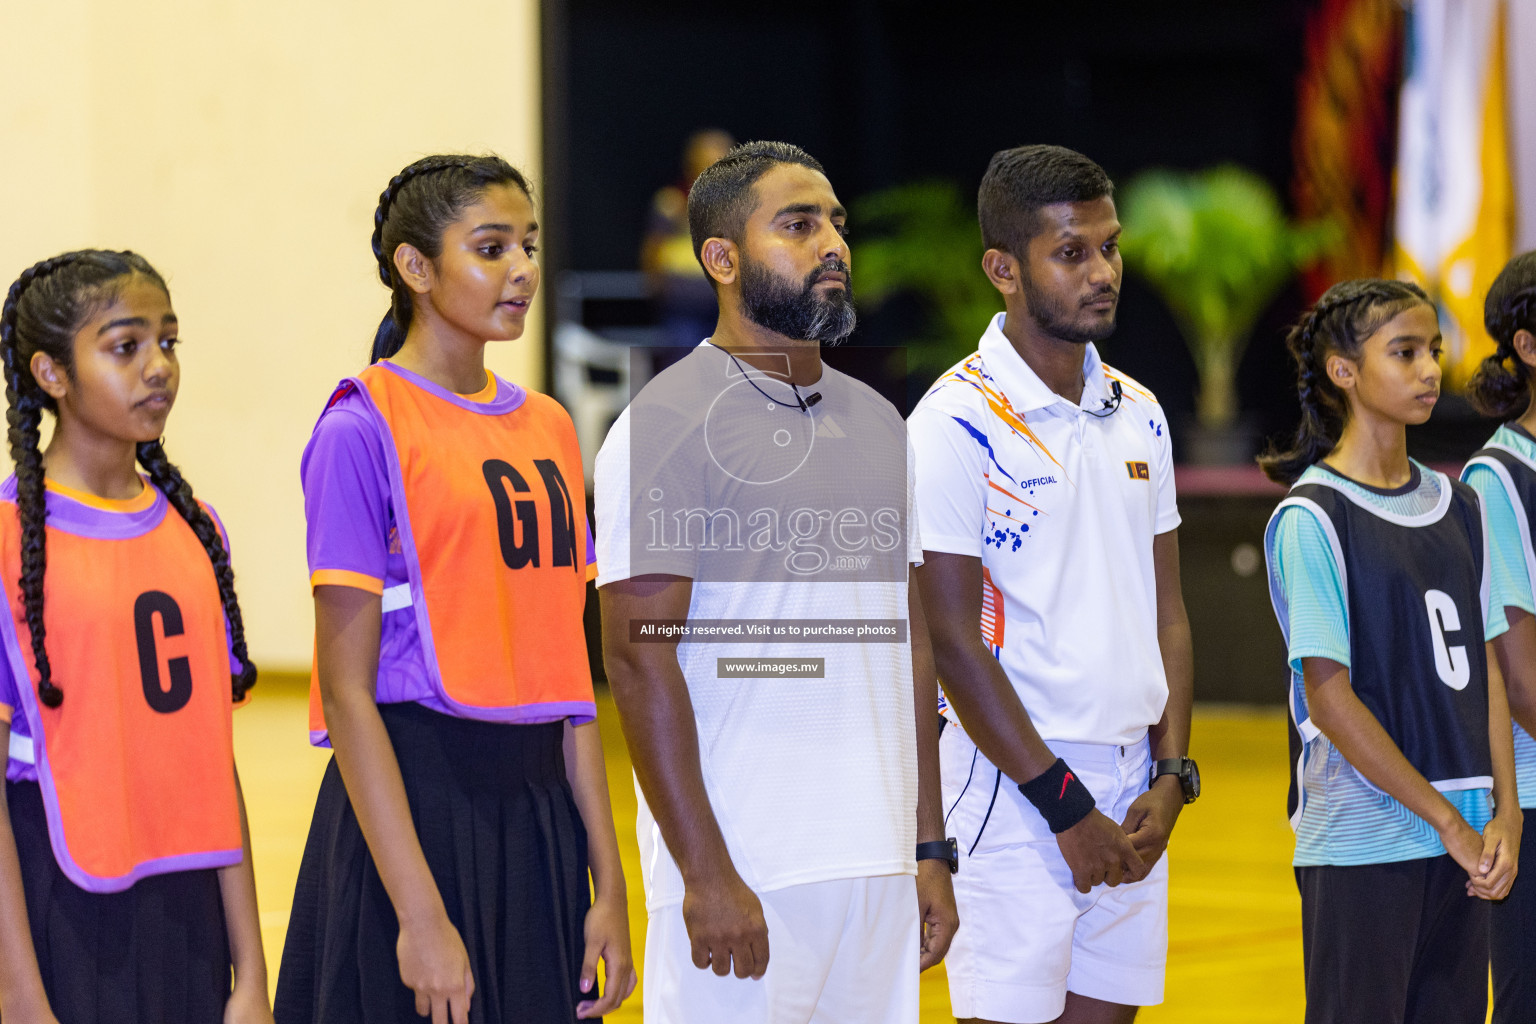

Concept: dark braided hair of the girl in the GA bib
[[369, 154, 533, 362]]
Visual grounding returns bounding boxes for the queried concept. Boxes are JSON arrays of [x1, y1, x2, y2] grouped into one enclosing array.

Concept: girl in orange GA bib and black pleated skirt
[[275, 155, 636, 1024]]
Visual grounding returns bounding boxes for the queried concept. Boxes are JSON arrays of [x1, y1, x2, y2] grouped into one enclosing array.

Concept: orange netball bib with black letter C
[[0, 477, 241, 892]]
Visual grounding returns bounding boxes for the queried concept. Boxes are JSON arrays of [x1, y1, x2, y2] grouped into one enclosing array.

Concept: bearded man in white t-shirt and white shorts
[[596, 143, 957, 1024]]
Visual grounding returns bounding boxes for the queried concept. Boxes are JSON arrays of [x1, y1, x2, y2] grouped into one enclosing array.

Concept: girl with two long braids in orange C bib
[[0, 250, 272, 1024]]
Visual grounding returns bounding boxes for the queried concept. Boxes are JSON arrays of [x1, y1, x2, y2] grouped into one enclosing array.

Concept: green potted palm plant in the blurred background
[[1118, 166, 1338, 462]]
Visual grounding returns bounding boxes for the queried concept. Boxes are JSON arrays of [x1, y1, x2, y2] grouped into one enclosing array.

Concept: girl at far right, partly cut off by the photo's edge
[[1461, 252, 1536, 1024]]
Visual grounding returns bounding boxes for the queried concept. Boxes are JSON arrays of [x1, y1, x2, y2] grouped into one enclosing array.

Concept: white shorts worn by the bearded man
[[644, 875, 922, 1024]]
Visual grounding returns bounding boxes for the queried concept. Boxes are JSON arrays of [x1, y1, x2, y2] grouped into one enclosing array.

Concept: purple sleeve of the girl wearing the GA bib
[[300, 395, 390, 590]]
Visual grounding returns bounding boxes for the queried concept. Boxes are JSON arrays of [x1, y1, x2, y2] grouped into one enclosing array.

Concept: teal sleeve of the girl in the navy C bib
[[1270, 507, 1349, 672]]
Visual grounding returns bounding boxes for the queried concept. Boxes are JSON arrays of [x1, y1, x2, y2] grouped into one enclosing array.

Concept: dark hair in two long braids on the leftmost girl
[[0, 249, 257, 708]]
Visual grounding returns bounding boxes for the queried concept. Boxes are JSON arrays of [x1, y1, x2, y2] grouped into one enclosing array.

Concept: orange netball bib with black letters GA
[[317, 362, 596, 722]]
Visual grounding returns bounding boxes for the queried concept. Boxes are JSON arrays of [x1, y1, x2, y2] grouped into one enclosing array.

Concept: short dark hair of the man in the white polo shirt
[[975, 146, 1115, 258]]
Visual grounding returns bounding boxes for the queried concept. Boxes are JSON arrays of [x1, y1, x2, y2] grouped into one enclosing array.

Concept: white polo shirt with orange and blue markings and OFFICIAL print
[[908, 313, 1180, 745]]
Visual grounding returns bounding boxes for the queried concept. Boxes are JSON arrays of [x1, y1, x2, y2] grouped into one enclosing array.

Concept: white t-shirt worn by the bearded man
[[594, 344, 922, 909]]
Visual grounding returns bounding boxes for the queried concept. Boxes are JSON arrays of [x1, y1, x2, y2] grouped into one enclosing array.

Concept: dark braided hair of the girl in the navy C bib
[[1258, 278, 1430, 484]]
